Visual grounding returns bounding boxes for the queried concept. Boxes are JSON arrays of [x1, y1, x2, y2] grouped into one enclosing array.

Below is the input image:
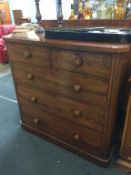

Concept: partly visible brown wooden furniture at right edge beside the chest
[[117, 77, 131, 172]]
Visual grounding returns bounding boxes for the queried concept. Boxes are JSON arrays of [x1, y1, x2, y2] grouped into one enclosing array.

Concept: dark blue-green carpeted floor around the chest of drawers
[[0, 75, 126, 175]]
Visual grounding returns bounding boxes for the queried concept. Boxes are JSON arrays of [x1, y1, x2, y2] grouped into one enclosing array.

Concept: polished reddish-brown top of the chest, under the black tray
[[5, 31, 130, 54]]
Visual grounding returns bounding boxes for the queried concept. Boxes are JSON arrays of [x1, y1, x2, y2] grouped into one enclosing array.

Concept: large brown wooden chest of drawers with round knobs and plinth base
[[5, 31, 130, 166]]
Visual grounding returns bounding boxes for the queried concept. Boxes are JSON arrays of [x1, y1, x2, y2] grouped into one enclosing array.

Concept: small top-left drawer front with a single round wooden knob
[[7, 43, 49, 67]]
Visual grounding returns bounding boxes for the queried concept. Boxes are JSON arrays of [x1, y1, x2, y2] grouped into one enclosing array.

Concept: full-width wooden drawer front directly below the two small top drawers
[[13, 62, 108, 109]]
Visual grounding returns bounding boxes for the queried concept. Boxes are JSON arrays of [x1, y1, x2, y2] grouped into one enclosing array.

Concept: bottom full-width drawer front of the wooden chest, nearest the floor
[[21, 104, 102, 153]]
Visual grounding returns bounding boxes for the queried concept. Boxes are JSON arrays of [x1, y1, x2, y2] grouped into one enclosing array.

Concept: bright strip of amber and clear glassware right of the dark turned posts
[[62, 0, 131, 20]]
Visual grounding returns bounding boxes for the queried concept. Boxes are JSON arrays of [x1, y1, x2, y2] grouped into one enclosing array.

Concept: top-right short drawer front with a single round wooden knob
[[52, 49, 112, 79]]
